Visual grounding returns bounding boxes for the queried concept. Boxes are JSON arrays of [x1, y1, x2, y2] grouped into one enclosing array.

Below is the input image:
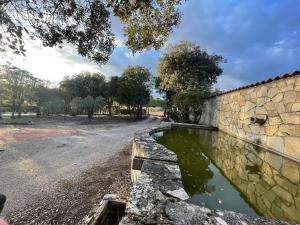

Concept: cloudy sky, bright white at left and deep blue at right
[[1, 0, 300, 90]]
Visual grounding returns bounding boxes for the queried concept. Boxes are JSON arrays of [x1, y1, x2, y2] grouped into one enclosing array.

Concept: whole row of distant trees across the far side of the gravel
[[0, 66, 153, 119]]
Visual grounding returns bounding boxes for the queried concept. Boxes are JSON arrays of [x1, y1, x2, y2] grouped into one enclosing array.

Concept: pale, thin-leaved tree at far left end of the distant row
[[0, 66, 40, 118]]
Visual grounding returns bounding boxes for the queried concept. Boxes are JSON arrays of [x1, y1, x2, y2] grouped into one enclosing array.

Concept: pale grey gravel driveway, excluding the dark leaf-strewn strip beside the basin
[[0, 118, 160, 223]]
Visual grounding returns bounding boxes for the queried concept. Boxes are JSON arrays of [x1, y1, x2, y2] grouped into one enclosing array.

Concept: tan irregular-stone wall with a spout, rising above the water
[[200, 73, 300, 159]]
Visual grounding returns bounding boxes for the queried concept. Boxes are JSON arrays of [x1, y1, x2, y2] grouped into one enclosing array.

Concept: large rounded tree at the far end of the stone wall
[[156, 41, 224, 121]]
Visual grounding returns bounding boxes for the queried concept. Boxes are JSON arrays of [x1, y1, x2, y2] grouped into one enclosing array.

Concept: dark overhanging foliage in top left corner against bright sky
[[0, 0, 114, 63]]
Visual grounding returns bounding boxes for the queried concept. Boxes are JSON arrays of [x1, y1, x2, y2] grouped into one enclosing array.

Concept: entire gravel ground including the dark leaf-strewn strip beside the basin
[[0, 118, 160, 224]]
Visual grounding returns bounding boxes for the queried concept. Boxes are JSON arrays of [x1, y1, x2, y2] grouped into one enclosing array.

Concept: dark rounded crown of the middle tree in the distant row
[[60, 72, 105, 102]]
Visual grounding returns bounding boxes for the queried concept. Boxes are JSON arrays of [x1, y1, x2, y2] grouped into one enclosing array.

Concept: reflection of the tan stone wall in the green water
[[210, 132, 300, 223]]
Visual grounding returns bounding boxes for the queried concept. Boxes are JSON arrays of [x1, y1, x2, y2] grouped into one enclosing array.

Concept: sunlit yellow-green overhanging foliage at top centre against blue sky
[[108, 0, 183, 53]]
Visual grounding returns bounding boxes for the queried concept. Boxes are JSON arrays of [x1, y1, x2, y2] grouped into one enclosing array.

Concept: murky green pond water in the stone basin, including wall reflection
[[154, 128, 300, 223]]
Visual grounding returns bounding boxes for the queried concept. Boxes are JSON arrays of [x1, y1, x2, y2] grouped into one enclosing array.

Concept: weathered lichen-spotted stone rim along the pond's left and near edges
[[120, 123, 288, 225]]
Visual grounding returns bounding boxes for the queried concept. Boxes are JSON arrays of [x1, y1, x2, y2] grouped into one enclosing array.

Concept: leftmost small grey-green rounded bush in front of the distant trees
[[41, 98, 66, 116]]
